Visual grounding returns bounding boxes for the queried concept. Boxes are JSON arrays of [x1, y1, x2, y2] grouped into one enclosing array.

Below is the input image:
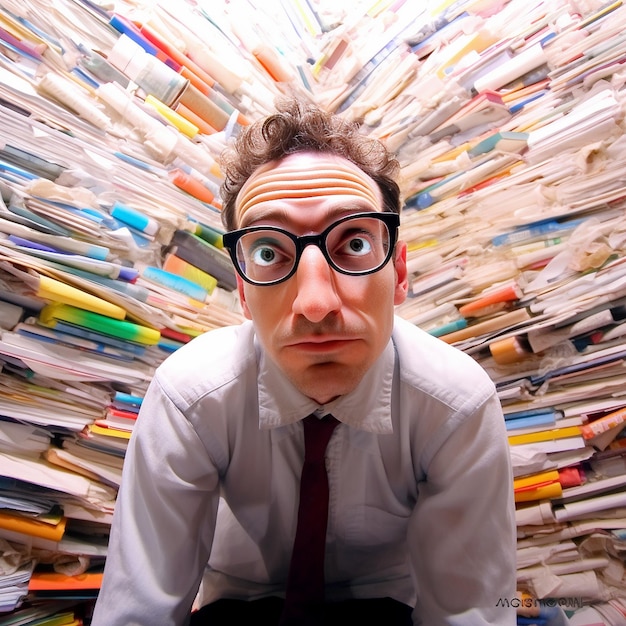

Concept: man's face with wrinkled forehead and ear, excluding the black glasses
[[236, 152, 407, 404]]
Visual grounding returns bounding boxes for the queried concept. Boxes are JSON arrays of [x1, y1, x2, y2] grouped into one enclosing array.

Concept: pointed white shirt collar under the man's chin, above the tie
[[257, 339, 395, 434]]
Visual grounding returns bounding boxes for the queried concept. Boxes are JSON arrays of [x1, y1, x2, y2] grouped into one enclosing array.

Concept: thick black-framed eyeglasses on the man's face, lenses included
[[224, 211, 400, 285]]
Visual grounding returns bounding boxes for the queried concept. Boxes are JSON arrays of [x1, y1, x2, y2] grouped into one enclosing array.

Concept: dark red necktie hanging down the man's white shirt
[[280, 415, 338, 626]]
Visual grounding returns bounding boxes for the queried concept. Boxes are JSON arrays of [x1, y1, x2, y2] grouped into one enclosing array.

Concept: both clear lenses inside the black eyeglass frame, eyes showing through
[[237, 217, 390, 283]]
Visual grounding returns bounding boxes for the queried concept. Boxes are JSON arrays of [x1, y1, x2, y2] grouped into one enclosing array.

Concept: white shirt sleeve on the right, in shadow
[[408, 388, 516, 626]]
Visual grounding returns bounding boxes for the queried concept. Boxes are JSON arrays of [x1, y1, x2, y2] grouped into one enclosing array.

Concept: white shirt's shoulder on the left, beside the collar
[[154, 321, 257, 405]]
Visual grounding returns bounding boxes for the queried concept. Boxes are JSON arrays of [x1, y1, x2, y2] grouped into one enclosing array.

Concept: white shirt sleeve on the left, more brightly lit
[[92, 376, 219, 626]]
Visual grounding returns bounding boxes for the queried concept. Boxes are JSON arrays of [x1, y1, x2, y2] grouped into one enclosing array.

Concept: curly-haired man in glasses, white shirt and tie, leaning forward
[[93, 101, 515, 626]]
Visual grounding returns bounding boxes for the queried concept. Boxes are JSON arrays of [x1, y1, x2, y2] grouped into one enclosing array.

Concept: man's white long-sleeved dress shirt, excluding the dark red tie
[[93, 318, 516, 626]]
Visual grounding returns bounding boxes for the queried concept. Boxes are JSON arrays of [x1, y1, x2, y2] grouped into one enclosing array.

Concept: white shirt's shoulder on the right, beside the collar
[[392, 317, 495, 410]]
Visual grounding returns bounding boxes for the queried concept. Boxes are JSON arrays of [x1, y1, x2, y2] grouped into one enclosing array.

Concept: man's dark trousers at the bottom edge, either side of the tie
[[189, 597, 413, 626]]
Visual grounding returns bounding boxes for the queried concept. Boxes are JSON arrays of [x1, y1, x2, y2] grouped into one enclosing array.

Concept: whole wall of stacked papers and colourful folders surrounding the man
[[0, 0, 626, 626]]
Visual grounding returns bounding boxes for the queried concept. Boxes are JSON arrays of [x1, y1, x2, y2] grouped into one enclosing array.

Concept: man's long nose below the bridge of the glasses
[[292, 245, 341, 323]]
